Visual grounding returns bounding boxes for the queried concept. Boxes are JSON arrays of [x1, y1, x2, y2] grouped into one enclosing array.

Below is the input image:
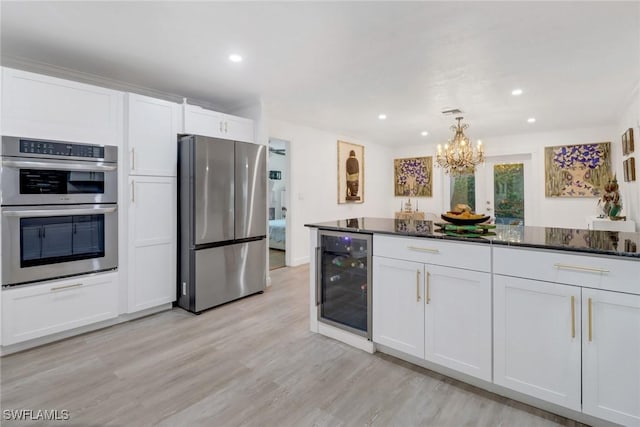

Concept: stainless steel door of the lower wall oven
[[0, 204, 118, 286]]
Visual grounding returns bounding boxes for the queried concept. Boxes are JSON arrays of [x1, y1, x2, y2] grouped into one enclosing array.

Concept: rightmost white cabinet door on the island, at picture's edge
[[582, 289, 640, 426]]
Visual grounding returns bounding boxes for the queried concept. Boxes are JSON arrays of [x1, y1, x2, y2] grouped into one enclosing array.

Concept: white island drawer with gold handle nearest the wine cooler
[[373, 235, 491, 272]]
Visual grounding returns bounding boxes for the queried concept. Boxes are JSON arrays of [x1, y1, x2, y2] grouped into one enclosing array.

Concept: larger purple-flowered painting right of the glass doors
[[544, 142, 611, 197]]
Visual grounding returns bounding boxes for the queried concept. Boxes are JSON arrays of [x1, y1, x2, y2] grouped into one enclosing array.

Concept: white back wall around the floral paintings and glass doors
[[389, 123, 624, 228]]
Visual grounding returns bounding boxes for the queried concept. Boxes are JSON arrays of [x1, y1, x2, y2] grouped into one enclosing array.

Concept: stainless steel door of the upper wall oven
[[0, 156, 118, 206]]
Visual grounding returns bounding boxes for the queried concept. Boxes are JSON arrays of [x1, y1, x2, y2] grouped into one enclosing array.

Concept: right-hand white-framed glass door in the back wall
[[476, 154, 533, 225]]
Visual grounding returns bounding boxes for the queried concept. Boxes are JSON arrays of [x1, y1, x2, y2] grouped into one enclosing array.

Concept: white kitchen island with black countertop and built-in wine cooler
[[307, 218, 640, 425]]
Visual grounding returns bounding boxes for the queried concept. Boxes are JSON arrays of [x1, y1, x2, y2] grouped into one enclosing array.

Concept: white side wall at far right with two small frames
[[612, 82, 640, 231]]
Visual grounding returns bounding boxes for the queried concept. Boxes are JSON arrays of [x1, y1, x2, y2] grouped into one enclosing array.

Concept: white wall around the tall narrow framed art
[[268, 120, 393, 265]]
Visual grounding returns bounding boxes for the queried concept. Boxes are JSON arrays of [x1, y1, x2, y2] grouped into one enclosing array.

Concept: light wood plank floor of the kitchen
[[0, 266, 592, 427]]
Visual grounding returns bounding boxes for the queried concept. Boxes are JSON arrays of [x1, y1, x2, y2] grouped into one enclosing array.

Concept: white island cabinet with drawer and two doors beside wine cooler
[[373, 235, 492, 381]]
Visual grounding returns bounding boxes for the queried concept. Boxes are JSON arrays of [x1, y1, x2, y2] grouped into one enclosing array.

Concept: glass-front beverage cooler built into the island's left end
[[316, 230, 372, 339]]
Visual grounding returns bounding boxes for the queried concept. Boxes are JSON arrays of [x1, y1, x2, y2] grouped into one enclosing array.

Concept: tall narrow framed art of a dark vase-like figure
[[338, 141, 364, 203]]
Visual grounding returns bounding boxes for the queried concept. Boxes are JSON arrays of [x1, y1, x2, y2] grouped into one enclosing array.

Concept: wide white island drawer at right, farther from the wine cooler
[[493, 247, 640, 294]]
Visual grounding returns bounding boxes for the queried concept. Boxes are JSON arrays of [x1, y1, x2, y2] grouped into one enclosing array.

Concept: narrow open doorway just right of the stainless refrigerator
[[267, 138, 289, 270]]
